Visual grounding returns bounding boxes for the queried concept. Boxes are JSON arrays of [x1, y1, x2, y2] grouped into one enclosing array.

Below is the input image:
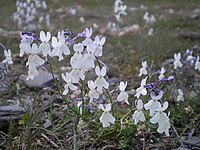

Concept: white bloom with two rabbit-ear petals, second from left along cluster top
[[39, 31, 51, 57]]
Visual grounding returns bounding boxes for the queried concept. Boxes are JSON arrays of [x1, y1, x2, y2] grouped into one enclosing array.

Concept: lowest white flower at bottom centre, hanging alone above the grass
[[99, 104, 115, 128]]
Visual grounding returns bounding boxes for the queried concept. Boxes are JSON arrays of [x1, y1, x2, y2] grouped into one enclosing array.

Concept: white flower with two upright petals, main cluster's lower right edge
[[95, 66, 109, 94]]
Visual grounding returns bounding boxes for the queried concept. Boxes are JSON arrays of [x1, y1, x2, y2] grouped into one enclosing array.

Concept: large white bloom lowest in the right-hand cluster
[[150, 102, 170, 136]]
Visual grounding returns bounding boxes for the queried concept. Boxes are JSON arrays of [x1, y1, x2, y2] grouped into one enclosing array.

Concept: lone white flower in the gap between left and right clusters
[[117, 81, 129, 104]]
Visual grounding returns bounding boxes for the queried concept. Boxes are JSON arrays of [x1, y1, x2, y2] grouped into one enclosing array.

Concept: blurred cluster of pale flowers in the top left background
[[13, 0, 50, 31]]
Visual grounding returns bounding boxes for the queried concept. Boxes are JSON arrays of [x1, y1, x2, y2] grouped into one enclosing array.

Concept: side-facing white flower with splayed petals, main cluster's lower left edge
[[61, 72, 78, 95]]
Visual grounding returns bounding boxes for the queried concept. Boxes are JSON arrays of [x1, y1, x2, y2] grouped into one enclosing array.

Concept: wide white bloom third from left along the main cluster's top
[[50, 31, 70, 61]]
